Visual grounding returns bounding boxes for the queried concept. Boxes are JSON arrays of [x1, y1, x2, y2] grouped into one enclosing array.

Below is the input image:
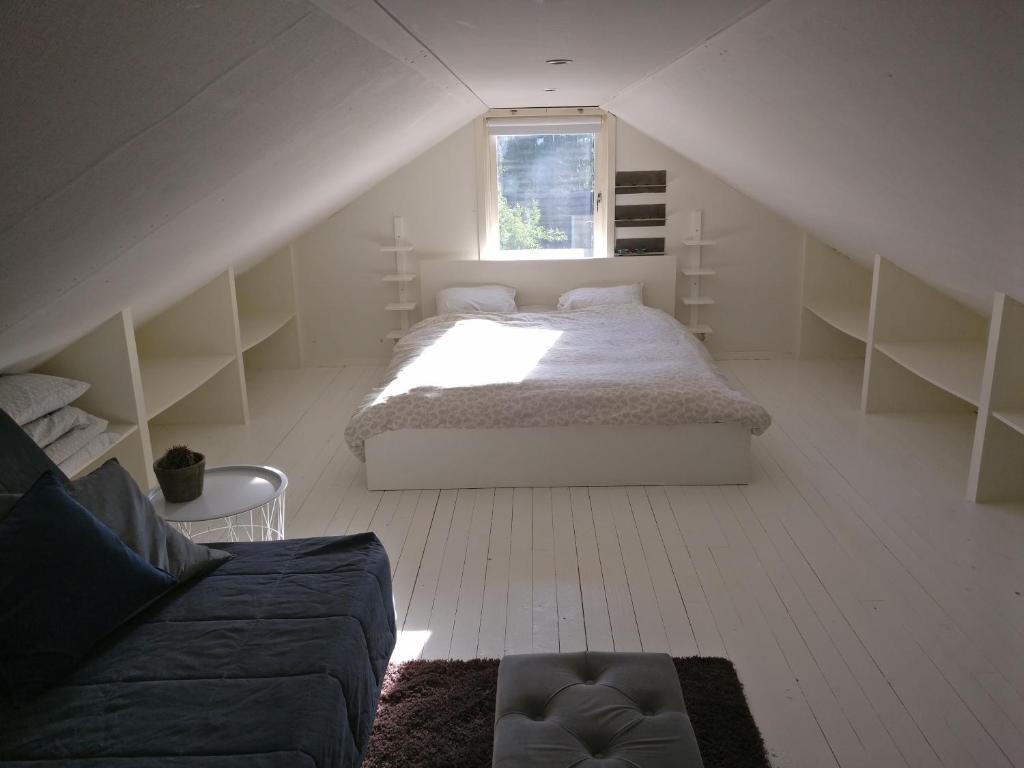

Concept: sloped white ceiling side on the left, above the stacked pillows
[[0, 0, 484, 367]]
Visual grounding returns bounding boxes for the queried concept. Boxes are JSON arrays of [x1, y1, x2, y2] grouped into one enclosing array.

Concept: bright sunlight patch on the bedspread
[[375, 317, 562, 404]]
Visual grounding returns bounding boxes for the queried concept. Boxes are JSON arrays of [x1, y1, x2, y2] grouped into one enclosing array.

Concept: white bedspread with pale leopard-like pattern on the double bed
[[345, 304, 771, 460]]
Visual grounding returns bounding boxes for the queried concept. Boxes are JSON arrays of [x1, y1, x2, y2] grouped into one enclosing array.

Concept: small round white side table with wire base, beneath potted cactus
[[148, 464, 288, 542]]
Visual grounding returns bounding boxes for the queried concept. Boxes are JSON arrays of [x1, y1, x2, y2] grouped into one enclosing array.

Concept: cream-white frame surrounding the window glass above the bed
[[476, 106, 615, 260]]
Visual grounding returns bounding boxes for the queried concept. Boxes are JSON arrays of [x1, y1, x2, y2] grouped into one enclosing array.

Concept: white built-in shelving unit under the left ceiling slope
[[25, 249, 300, 487]]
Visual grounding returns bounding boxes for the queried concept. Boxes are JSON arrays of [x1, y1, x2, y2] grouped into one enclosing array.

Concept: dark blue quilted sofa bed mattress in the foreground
[[0, 534, 395, 768]]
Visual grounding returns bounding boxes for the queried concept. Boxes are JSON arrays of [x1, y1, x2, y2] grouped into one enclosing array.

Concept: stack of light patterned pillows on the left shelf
[[0, 374, 118, 477]]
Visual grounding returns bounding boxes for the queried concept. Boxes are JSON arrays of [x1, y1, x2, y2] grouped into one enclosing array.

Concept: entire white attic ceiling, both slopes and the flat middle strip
[[0, 0, 1024, 369]]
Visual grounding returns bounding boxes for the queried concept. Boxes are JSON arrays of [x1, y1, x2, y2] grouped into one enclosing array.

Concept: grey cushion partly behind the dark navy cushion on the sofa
[[67, 459, 231, 582]]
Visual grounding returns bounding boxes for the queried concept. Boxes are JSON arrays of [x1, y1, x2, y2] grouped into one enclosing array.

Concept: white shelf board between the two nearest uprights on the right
[[874, 341, 985, 407]]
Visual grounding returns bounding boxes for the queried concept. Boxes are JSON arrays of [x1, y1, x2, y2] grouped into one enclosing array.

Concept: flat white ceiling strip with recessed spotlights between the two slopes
[[372, 0, 766, 108]]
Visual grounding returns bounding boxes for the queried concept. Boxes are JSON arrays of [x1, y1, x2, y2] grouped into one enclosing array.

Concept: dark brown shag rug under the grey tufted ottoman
[[362, 656, 770, 768]]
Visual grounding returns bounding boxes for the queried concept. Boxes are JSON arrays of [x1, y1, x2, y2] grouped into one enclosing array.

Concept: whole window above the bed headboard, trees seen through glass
[[480, 110, 608, 259]]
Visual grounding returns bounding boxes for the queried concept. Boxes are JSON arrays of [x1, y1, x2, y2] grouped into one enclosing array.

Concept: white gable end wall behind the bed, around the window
[[295, 121, 802, 366]]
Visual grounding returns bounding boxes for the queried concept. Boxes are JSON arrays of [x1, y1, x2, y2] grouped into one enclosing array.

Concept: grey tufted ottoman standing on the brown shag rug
[[493, 651, 703, 768]]
